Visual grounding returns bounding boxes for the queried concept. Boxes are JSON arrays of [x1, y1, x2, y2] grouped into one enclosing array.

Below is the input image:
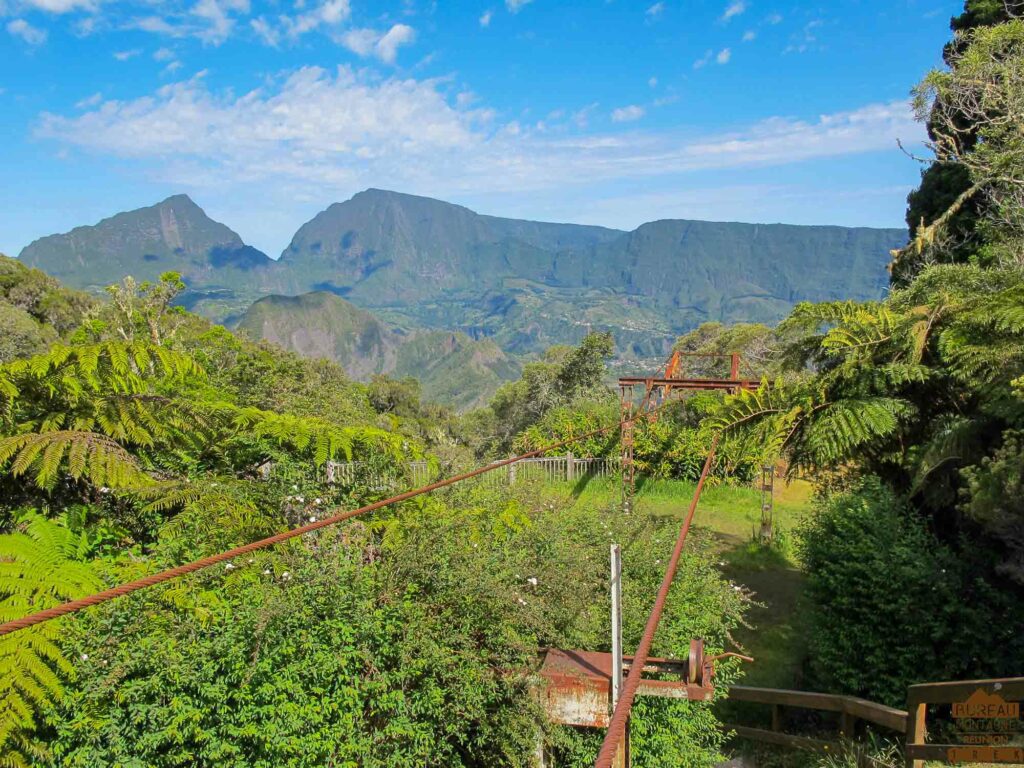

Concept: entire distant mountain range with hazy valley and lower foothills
[[19, 189, 906, 408]]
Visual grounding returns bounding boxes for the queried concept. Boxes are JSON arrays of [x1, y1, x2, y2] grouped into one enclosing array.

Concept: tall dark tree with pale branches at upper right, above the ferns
[[892, 9, 1024, 286]]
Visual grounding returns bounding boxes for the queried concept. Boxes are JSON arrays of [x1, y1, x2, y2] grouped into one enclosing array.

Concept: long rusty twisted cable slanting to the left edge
[[0, 409, 660, 637]]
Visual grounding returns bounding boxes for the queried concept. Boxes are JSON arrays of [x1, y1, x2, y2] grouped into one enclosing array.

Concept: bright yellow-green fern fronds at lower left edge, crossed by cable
[[0, 513, 103, 766]]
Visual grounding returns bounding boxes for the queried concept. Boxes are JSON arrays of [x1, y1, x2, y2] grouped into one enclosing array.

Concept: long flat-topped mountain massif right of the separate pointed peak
[[281, 189, 906, 357]]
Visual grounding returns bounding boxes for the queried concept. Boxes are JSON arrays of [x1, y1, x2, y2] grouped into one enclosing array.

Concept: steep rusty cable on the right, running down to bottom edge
[[594, 434, 718, 768]]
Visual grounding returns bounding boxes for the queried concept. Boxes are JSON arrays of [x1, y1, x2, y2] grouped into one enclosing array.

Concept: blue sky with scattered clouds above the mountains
[[0, 0, 962, 256]]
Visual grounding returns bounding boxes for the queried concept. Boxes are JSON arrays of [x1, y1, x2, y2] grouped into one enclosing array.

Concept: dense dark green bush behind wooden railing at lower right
[[799, 478, 1024, 706]]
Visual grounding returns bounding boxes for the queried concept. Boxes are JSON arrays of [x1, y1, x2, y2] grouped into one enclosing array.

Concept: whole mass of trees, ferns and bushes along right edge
[[705, 2, 1024, 703]]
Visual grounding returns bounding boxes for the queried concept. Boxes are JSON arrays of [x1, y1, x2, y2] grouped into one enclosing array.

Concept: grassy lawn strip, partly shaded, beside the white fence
[[540, 478, 811, 692]]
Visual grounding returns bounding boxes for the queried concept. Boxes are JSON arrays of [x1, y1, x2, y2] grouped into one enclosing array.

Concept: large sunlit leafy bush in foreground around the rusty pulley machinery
[[41, 487, 744, 768]]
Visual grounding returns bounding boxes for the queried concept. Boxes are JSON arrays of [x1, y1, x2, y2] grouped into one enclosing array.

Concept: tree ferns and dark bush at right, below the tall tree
[[705, 265, 1024, 702]]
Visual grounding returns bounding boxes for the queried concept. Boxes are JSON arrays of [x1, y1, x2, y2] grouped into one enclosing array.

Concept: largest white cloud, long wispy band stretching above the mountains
[[36, 68, 924, 207]]
